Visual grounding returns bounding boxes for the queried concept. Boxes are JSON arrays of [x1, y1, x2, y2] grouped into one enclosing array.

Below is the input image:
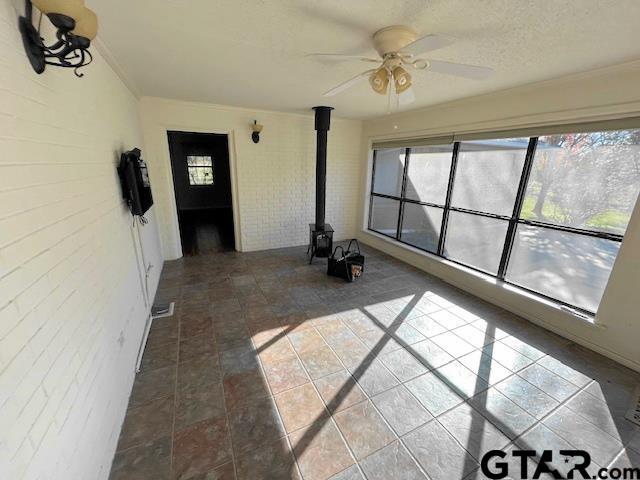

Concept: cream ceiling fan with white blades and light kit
[[308, 25, 493, 105]]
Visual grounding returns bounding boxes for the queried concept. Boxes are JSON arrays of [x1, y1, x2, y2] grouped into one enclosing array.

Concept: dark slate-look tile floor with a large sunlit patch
[[111, 244, 640, 480]]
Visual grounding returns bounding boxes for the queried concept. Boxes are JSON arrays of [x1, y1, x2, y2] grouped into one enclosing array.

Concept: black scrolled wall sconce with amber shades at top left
[[18, 0, 98, 77]]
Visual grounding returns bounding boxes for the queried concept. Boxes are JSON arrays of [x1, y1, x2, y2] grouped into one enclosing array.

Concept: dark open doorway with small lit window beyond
[[167, 131, 235, 256]]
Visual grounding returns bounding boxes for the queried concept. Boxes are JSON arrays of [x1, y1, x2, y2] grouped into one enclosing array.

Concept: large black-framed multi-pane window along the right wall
[[369, 130, 640, 313]]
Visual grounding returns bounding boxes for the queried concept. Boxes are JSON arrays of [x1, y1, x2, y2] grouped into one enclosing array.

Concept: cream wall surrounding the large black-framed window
[[359, 61, 640, 371]]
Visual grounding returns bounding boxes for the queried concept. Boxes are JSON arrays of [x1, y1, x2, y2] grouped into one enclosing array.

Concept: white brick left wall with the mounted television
[[0, 0, 162, 479]]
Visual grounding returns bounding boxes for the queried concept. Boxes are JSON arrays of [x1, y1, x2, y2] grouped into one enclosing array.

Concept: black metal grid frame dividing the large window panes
[[367, 133, 624, 317]]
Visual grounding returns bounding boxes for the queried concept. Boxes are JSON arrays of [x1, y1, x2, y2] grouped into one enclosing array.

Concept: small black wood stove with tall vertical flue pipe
[[307, 107, 333, 263]]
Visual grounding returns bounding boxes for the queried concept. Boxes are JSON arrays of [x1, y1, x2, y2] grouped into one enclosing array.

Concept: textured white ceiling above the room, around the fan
[[87, 0, 640, 118]]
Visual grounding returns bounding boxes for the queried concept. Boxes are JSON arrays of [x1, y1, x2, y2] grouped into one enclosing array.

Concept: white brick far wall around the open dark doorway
[[140, 97, 362, 259]]
